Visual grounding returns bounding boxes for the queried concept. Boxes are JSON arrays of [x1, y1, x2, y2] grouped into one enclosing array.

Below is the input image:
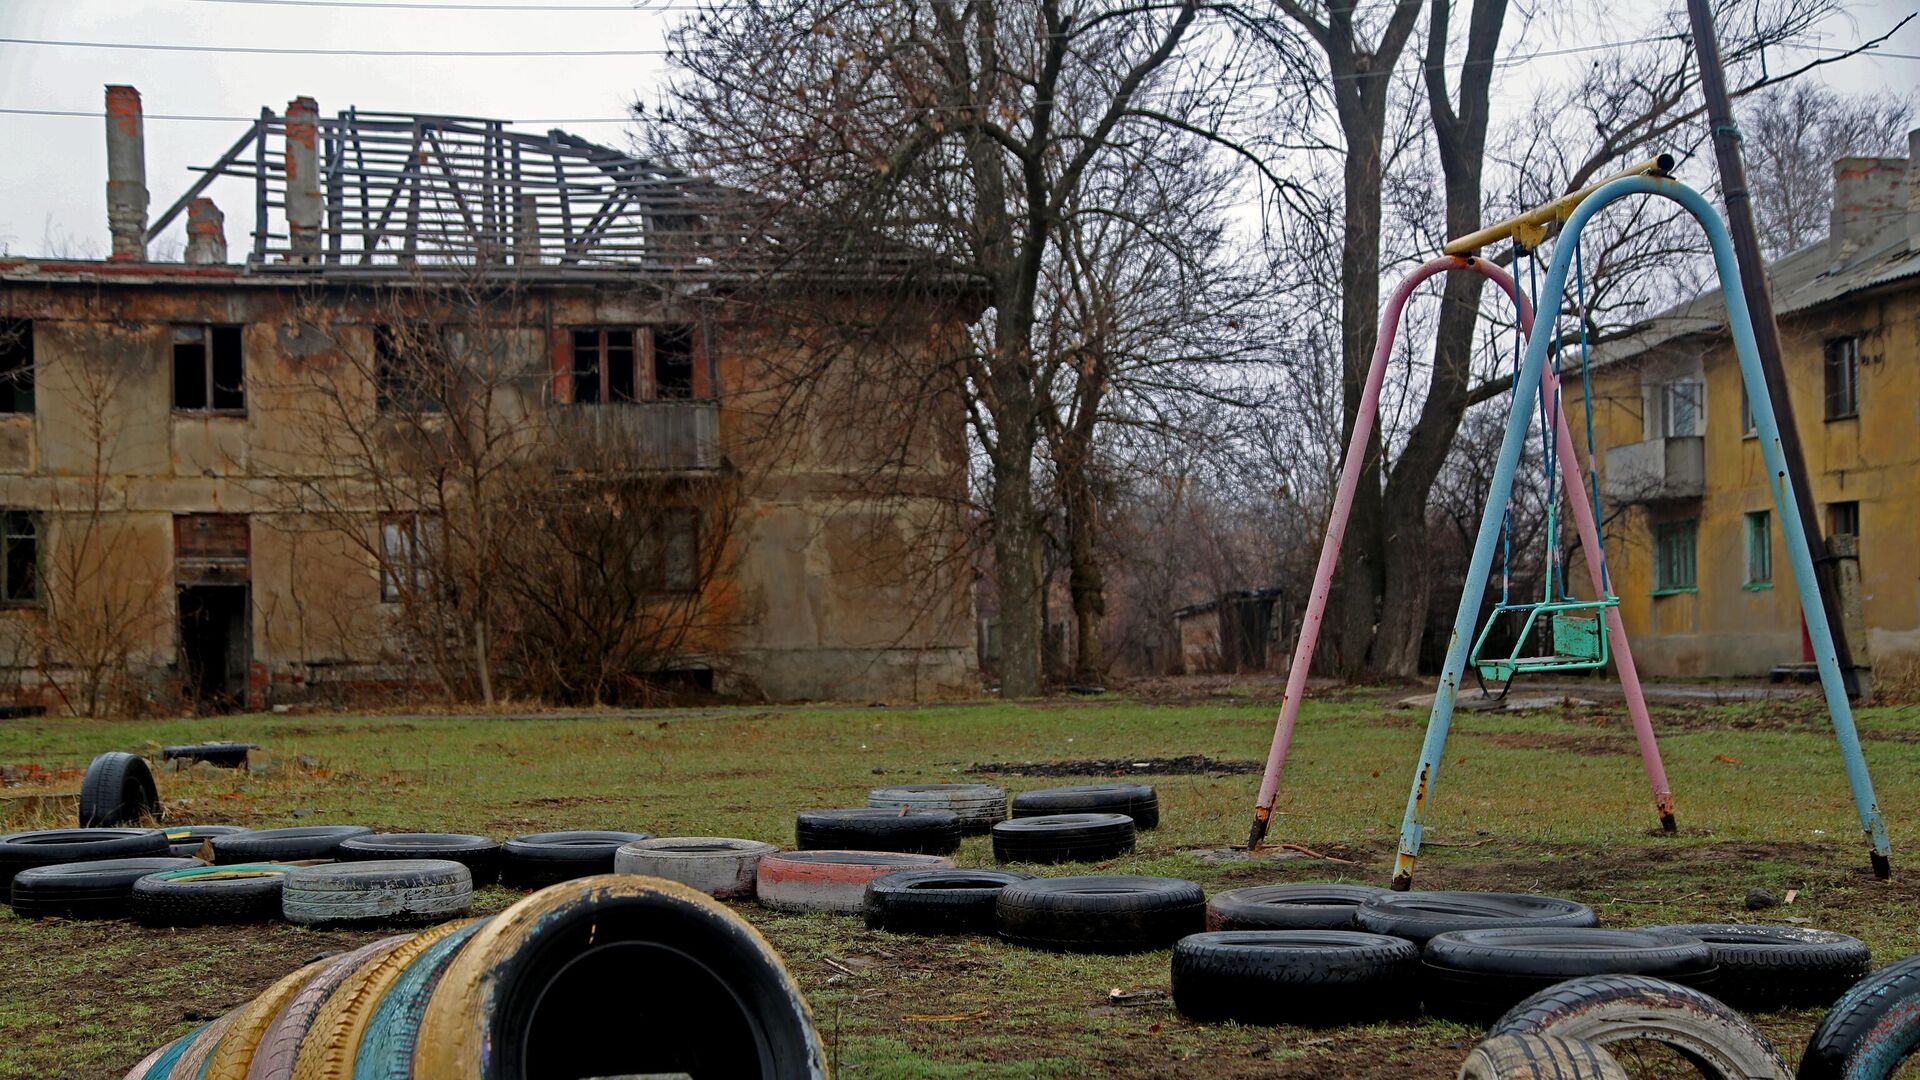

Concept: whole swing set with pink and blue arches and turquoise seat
[[1248, 154, 1891, 890]]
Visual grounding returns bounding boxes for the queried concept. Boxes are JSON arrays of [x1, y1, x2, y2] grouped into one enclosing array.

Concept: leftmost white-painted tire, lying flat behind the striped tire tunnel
[[280, 859, 474, 926]]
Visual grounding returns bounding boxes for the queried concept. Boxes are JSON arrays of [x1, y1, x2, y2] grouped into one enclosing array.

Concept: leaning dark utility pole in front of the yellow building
[[1686, 0, 1868, 700]]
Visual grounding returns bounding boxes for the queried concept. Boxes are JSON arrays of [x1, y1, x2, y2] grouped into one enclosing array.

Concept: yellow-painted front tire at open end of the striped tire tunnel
[[413, 874, 828, 1080]]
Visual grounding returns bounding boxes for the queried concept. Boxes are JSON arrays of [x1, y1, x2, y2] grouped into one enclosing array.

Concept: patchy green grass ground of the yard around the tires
[[0, 692, 1920, 1078]]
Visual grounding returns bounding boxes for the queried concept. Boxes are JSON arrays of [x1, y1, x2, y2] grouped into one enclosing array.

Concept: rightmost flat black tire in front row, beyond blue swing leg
[[1653, 922, 1874, 1011]]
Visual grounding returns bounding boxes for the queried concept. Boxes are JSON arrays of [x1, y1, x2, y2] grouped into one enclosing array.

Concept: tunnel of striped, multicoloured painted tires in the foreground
[[127, 874, 826, 1080]]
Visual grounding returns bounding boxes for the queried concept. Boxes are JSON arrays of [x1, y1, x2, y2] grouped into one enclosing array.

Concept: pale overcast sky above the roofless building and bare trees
[[0, 0, 1920, 261]]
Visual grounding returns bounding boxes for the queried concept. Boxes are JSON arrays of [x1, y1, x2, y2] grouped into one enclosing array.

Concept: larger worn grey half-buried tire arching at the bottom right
[[1492, 974, 1788, 1080]]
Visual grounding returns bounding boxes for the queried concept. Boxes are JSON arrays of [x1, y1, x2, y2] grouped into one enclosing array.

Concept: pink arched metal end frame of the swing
[[1246, 256, 1678, 851]]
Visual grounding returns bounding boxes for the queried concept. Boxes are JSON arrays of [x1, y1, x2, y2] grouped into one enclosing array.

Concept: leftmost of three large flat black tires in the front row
[[1173, 930, 1421, 1024]]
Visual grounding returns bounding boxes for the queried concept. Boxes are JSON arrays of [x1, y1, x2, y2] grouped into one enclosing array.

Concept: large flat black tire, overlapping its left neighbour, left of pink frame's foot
[[995, 874, 1206, 953]]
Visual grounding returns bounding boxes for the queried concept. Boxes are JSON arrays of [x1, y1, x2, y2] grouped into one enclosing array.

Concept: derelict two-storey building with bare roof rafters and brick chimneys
[[0, 86, 977, 715]]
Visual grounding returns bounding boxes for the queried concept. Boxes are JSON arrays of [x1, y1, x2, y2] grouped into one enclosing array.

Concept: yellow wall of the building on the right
[[1569, 284, 1920, 676]]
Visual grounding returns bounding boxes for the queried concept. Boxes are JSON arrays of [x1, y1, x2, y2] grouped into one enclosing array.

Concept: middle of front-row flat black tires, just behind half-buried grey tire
[[1421, 926, 1713, 1024]]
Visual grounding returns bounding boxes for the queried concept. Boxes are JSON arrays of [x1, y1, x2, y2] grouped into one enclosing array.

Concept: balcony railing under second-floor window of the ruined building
[[555, 402, 720, 473]]
